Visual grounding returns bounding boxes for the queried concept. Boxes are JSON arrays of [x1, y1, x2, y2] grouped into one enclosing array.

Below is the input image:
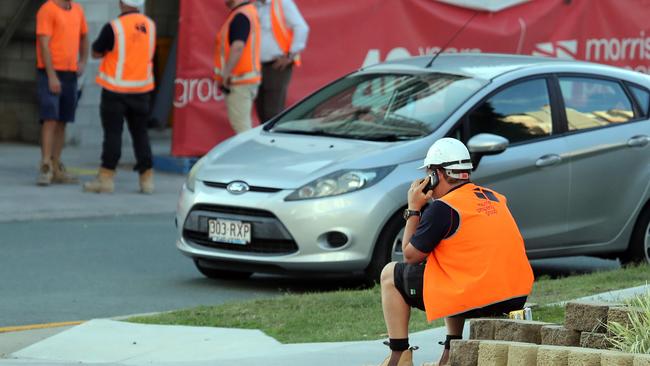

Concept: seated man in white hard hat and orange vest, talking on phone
[[374, 138, 534, 366]]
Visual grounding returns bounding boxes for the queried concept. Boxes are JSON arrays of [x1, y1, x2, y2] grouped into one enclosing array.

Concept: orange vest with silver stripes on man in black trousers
[[96, 13, 156, 93]]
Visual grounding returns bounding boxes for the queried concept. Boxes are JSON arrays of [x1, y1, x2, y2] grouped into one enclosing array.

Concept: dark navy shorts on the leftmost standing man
[[36, 70, 78, 123]]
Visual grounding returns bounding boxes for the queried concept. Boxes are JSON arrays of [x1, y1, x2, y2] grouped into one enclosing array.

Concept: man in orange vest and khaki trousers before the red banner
[[214, 0, 262, 133]]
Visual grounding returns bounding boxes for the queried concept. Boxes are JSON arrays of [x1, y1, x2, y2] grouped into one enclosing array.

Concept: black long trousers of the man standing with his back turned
[[99, 89, 153, 173]]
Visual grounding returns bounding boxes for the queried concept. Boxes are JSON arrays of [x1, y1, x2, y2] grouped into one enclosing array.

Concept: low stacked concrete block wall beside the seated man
[[464, 303, 650, 366]]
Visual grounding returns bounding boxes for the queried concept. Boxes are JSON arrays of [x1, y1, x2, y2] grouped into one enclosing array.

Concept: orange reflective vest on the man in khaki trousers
[[214, 4, 262, 85]]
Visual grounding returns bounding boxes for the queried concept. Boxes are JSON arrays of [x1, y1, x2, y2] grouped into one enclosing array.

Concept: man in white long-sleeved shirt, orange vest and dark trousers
[[255, 0, 309, 122]]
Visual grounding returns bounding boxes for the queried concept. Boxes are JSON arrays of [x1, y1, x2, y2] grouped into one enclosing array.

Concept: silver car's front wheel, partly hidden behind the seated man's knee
[[365, 211, 404, 283]]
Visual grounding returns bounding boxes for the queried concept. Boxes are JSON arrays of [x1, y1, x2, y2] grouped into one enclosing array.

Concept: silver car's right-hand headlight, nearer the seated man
[[285, 165, 395, 201]]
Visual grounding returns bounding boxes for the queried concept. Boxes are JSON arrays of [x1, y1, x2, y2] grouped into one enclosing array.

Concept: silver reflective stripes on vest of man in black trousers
[[99, 19, 156, 88]]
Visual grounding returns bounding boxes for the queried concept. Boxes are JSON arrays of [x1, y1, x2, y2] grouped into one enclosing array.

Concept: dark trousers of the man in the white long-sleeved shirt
[[255, 62, 293, 123]]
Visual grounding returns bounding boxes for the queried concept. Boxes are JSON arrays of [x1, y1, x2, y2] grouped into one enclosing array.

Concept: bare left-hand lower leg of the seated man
[[381, 262, 411, 365]]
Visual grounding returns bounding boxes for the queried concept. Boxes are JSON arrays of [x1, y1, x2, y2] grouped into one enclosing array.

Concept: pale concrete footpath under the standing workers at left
[[0, 132, 185, 222]]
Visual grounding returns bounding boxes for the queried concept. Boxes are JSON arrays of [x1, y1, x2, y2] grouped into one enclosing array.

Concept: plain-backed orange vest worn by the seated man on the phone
[[422, 183, 534, 321]]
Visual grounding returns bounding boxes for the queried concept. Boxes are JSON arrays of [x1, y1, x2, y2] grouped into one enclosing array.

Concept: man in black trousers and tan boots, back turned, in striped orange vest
[[83, 0, 156, 194]]
